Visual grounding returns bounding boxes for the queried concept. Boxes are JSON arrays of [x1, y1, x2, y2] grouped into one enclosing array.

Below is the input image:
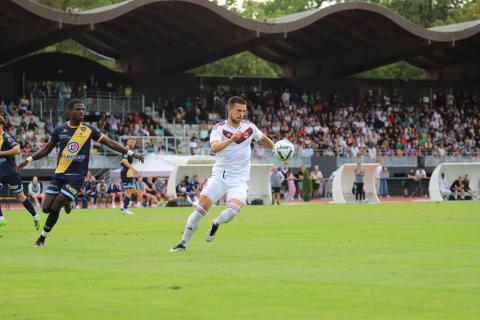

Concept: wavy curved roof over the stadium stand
[[0, 0, 480, 75]]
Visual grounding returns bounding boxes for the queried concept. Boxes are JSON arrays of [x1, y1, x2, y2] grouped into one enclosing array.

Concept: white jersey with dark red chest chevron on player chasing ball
[[210, 120, 263, 180]]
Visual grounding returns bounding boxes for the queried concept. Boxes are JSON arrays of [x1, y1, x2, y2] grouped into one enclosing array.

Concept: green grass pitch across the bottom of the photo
[[0, 203, 480, 320]]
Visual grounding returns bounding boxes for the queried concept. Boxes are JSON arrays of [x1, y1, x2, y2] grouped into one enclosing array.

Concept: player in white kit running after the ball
[[170, 96, 273, 252]]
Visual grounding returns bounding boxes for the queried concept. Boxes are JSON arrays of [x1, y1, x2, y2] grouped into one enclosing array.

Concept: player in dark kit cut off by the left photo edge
[[0, 116, 40, 230]]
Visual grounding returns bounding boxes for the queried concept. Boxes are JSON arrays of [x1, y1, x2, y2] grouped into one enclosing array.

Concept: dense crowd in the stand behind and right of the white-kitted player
[[159, 89, 480, 158]]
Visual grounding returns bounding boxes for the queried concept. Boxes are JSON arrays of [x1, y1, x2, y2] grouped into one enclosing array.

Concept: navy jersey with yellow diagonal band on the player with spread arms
[[52, 122, 104, 176]]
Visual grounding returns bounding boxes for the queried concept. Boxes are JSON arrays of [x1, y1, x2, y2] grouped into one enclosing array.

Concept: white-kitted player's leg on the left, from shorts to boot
[[170, 176, 225, 252]]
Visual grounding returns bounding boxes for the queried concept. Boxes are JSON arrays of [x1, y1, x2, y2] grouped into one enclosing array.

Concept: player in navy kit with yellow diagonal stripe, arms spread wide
[[18, 99, 143, 247]]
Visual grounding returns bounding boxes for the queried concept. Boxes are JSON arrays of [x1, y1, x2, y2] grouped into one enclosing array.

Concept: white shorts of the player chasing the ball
[[201, 174, 248, 203]]
